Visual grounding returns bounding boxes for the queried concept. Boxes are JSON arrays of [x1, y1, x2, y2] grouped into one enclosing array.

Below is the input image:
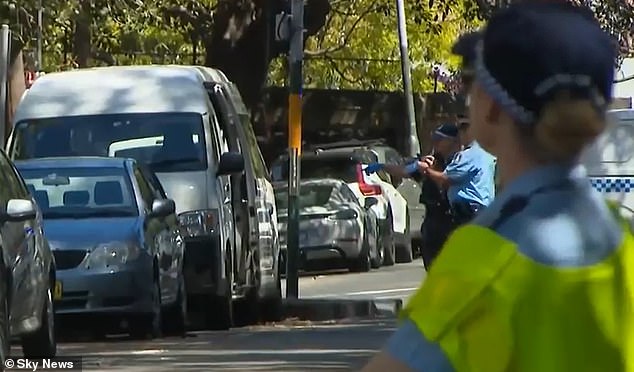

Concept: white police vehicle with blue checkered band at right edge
[[581, 109, 634, 219]]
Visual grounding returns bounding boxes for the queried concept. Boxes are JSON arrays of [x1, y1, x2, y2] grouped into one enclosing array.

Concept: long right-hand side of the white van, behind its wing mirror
[[192, 66, 285, 321]]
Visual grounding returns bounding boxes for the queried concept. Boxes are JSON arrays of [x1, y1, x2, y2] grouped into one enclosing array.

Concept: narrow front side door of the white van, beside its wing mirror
[[205, 84, 253, 285]]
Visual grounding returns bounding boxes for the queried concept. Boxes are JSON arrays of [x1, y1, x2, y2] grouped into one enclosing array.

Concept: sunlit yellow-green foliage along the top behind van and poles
[[7, 0, 634, 91]]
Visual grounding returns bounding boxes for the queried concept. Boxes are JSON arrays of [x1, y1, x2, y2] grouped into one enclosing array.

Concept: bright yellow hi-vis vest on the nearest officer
[[402, 209, 634, 372]]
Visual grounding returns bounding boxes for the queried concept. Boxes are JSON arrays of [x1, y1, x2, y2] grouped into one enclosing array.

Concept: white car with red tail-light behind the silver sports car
[[271, 144, 412, 265]]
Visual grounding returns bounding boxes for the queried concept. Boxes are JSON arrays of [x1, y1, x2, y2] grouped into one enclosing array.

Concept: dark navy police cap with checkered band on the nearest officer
[[475, 1, 617, 125]]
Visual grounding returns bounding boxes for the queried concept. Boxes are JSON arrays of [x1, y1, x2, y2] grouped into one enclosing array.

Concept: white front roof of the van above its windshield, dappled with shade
[[14, 65, 214, 122]]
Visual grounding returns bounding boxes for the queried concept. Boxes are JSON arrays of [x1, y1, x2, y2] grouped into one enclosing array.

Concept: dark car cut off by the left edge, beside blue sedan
[[0, 151, 60, 358]]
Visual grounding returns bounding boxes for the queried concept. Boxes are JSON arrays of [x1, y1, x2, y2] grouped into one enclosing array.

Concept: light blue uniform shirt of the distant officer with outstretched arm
[[445, 141, 495, 206]]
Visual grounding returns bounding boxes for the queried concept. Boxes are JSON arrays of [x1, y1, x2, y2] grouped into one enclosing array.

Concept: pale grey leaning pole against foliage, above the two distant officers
[[396, 0, 420, 156]]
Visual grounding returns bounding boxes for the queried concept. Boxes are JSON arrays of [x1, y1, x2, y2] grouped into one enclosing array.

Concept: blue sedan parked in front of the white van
[[17, 157, 187, 337]]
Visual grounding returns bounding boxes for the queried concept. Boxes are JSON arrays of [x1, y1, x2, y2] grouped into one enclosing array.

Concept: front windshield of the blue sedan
[[20, 167, 138, 219]]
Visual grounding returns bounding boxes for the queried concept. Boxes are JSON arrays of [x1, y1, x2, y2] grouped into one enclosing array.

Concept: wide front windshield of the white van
[[11, 113, 207, 172]]
